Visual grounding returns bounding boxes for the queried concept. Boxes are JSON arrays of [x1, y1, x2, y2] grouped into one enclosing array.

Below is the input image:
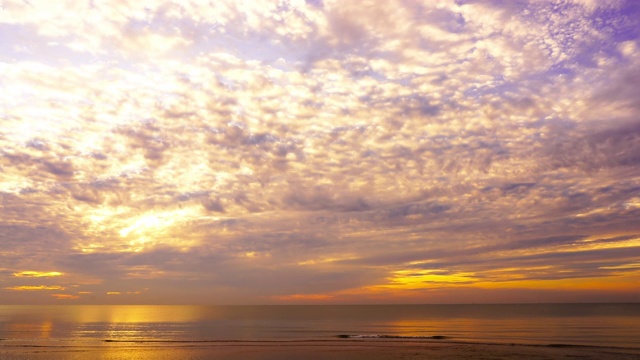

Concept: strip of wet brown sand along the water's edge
[[0, 340, 640, 360]]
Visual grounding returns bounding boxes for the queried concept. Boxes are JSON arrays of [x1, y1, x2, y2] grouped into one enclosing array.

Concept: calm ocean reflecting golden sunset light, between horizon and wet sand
[[0, 304, 640, 348]]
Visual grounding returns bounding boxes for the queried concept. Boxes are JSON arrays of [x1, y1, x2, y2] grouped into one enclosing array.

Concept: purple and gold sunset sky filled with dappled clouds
[[0, 0, 640, 304]]
